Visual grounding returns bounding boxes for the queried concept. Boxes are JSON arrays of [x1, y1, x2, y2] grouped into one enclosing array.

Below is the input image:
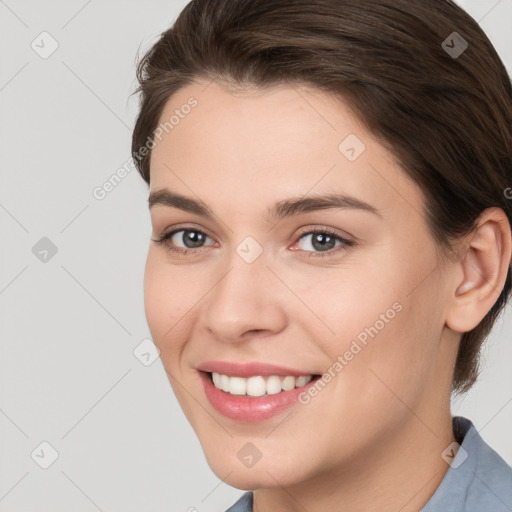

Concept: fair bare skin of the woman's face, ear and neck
[[144, 81, 511, 512]]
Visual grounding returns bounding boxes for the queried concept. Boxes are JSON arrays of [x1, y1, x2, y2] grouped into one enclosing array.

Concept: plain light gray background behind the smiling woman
[[0, 0, 512, 512]]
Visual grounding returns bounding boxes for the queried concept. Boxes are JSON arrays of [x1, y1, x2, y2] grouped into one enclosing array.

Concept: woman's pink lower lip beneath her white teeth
[[199, 371, 318, 423]]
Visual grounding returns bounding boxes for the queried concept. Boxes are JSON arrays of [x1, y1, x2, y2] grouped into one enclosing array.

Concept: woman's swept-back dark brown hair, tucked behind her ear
[[132, 0, 512, 393]]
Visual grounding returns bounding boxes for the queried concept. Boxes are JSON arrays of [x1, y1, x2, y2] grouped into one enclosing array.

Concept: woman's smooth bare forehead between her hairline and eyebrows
[[147, 82, 422, 221]]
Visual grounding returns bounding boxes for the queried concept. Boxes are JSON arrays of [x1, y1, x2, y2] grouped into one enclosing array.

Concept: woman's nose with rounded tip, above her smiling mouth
[[201, 249, 290, 343]]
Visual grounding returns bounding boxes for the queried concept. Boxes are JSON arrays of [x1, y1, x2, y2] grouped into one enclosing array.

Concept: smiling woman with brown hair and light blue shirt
[[132, 0, 512, 512]]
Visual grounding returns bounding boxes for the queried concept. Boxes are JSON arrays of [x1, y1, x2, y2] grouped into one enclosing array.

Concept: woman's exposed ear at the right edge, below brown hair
[[446, 208, 512, 333]]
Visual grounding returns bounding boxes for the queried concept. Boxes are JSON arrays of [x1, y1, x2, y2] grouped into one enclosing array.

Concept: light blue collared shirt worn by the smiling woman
[[225, 416, 512, 512]]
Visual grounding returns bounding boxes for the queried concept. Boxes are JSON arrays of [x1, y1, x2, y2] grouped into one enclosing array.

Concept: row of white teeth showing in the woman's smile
[[206, 372, 321, 398]]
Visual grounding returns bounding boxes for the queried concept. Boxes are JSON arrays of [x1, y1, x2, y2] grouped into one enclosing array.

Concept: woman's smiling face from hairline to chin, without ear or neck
[[145, 82, 455, 489]]
